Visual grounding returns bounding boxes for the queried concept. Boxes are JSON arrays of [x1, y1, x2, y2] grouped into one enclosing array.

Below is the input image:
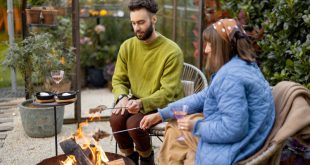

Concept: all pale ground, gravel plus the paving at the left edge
[[0, 89, 161, 165]]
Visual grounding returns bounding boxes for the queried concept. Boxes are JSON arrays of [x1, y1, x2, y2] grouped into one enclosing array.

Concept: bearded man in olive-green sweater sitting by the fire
[[110, 0, 183, 165]]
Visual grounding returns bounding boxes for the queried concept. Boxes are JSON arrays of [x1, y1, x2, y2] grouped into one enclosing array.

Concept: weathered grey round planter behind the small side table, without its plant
[[19, 99, 64, 138]]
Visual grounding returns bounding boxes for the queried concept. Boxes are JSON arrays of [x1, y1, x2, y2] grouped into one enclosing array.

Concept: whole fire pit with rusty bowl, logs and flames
[[38, 112, 135, 165]]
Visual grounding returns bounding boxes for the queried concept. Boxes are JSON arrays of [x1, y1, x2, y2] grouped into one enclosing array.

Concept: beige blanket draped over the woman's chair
[[238, 81, 310, 165]]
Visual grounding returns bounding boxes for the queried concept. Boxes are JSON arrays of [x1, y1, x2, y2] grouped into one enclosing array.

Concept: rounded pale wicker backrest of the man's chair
[[181, 63, 208, 96]]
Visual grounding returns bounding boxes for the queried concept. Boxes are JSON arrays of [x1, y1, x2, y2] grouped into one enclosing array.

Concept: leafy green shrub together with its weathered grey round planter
[[3, 33, 74, 137]]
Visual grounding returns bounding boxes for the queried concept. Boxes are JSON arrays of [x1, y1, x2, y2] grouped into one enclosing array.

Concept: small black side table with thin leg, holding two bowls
[[32, 100, 75, 156]]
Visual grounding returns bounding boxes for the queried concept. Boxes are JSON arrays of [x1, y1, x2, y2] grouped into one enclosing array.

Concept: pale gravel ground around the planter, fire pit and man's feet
[[0, 89, 161, 165]]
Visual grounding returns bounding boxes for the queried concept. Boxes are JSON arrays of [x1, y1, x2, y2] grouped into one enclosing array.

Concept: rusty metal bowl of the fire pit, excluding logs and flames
[[37, 152, 135, 165]]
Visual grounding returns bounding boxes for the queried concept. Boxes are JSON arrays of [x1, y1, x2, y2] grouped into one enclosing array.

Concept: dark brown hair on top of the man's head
[[128, 0, 158, 14]]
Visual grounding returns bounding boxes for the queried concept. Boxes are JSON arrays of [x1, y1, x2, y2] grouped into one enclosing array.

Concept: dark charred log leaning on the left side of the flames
[[60, 138, 93, 165]]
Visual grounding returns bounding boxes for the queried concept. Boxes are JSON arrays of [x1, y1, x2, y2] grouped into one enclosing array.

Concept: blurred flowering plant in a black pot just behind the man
[[80, 18, 131, 88]]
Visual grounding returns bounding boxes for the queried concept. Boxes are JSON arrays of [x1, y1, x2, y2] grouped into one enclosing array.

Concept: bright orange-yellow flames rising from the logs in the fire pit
[[61, 120, 109, 165]]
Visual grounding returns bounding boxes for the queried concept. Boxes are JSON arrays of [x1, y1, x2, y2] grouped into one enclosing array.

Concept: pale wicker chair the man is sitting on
[[150, 63, 208, 141]]
